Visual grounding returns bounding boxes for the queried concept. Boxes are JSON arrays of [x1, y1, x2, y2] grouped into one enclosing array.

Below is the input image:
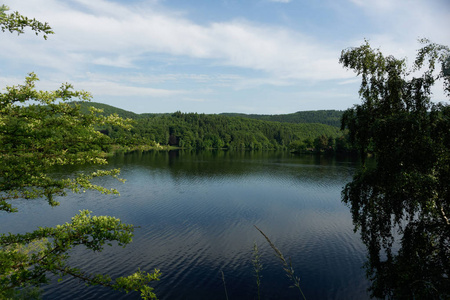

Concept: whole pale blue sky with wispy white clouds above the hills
[[0, 0, 450, 114]]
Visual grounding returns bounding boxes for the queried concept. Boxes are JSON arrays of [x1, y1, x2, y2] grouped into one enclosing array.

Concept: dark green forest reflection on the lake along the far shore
[[109, 150, 357, 185]]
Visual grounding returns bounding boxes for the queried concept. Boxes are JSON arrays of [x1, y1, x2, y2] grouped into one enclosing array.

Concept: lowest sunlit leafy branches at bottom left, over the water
[[0, 210, 161, 299]]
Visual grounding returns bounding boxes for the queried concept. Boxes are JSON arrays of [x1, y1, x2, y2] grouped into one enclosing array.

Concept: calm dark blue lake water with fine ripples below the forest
[[0, 151, 368, 300]]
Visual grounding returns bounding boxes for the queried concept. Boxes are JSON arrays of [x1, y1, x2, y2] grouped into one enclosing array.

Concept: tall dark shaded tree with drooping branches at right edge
[[340, 39, 450, 299]]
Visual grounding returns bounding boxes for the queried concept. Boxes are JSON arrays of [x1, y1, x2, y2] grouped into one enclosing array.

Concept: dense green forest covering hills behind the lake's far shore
[[74, 102, 356, 152]]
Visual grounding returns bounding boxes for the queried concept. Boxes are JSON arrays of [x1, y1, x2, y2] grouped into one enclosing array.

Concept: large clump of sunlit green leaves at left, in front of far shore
[[0, 73, 130, 212]]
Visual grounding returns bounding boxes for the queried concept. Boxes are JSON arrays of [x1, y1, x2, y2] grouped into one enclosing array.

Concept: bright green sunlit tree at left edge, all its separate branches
[[0, 6, 160, 299]]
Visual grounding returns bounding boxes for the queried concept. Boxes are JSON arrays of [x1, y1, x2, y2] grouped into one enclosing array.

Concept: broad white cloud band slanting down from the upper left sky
[[0, 0, 345, 80]]
